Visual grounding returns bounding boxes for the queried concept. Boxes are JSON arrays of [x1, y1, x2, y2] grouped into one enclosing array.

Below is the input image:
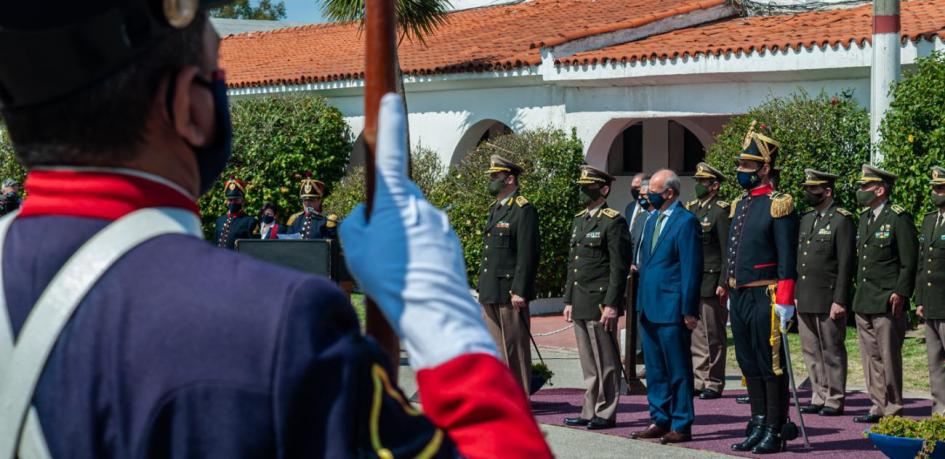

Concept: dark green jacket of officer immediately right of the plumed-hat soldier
[[795, 202, 856, 314]]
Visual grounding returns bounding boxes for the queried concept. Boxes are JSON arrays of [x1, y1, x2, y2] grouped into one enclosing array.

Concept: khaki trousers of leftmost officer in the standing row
[[482, 304, 532, 394]]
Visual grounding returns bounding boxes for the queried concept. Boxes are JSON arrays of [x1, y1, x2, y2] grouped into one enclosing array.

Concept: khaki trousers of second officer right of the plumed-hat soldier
[[856, 312, 906, 416]]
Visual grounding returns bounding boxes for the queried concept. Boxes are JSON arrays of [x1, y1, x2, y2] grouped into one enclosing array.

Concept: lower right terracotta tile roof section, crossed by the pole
[[556, 0, 945, 65]]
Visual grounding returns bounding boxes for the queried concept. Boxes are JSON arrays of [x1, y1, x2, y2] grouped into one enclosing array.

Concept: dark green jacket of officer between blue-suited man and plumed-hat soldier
[[686, 197, 731, 298]]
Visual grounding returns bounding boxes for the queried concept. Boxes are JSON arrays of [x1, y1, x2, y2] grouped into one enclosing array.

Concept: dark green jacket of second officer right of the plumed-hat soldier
[[853, 203, 918, 314]]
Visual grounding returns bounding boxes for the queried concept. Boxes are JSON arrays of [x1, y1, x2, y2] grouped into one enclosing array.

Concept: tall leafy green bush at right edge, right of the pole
[[880, 52, 945, 222]]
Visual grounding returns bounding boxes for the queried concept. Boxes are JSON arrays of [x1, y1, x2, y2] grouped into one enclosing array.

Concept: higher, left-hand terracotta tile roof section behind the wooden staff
[[221, 0, 725, 87]]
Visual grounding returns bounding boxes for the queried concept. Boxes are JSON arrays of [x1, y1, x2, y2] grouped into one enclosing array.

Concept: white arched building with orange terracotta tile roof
[[222, 0, 945, 208]]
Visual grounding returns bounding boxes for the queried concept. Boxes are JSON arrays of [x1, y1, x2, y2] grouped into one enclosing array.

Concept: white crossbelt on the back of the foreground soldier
[[0, 208, 201, 459]]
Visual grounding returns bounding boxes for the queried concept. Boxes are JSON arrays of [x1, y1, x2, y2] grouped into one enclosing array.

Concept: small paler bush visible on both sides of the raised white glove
[[324, 146, 443, 218]]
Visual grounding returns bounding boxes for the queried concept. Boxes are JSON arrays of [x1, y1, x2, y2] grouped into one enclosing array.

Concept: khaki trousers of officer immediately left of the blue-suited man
[[574, 320, 620, 421]]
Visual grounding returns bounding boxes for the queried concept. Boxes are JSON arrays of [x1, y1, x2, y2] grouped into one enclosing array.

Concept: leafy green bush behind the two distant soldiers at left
[[200, 96, 352, 235]]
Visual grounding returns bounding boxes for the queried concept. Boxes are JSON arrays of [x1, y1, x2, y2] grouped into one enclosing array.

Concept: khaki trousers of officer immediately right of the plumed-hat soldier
[[798, 313, 847, 409]]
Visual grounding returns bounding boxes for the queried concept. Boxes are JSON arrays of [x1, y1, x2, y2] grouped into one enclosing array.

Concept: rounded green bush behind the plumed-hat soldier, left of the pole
[[706, 92, 870, 211]]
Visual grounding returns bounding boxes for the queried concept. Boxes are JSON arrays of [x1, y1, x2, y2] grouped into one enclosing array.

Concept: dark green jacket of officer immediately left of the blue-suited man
[[564, 203, 631, 320]]
